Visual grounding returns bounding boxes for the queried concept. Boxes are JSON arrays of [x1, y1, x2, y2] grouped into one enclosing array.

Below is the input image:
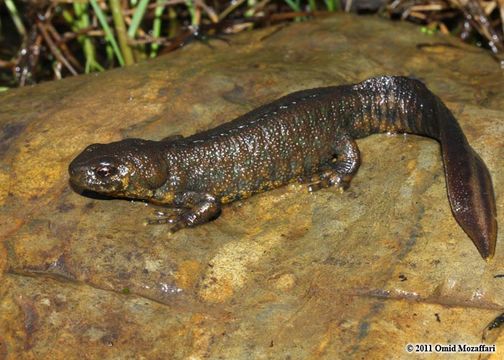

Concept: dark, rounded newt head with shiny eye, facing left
[[68, 139, 167, 199]]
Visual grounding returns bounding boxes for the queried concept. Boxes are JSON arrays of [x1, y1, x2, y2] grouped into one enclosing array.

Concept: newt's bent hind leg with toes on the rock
[[308, 135, 361, 192]]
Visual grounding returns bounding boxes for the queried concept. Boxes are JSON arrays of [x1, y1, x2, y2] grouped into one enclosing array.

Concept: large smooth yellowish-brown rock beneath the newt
[[0, 15, 504, 360]]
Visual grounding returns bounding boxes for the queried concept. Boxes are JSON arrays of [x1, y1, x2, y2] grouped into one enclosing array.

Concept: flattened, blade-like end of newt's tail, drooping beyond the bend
[[439, 105, 497, 260]]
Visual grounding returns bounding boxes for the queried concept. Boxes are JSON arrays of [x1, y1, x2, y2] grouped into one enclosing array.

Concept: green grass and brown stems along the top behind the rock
[[0, 0, 504, 90]]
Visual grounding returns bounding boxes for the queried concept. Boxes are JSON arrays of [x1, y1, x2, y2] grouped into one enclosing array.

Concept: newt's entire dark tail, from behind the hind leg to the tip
[[355, 77, 497, 259]]
